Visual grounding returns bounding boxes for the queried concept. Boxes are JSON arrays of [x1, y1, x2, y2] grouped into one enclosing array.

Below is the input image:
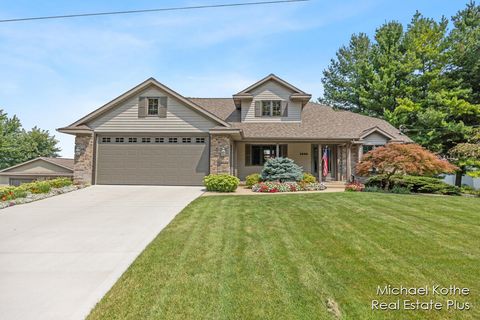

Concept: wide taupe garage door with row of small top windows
[[96, 136, 209, 186]]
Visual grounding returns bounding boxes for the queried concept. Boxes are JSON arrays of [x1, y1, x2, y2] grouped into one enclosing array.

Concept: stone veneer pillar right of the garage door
[[210, 135, 232, 174]]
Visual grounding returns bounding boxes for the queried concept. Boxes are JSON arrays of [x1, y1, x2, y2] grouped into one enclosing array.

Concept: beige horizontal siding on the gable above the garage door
[[88, 87, 217, 132]]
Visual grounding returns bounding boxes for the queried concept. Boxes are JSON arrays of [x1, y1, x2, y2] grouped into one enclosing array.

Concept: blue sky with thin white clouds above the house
[[0, 0, 466, 157]]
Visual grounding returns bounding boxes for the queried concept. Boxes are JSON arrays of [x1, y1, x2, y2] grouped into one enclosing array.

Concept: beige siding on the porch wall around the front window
[[235, 141, 312, 180]]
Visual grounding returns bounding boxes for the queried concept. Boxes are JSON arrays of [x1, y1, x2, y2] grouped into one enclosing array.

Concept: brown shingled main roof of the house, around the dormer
[[189, 98, 411, 142]]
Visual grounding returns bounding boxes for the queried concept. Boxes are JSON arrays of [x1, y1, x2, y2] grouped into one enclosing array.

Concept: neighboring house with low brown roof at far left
[[0, 157, 73, 186]]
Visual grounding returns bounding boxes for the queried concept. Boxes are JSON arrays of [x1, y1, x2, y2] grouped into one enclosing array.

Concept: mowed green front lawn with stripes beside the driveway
[[89, 193, 480, 319]]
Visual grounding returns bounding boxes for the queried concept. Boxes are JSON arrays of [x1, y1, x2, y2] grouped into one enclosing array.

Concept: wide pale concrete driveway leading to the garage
[[0, 186, 202, 319]]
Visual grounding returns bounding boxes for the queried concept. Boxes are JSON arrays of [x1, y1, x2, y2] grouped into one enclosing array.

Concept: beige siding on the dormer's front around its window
[[241, 81, 302, 122]]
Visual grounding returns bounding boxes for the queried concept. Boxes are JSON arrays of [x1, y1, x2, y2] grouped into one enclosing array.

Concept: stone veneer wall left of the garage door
[[73, 134, 94, 184]]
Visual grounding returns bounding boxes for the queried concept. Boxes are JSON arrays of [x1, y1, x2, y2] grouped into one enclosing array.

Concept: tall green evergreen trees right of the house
[[320, 2, 480, 154]]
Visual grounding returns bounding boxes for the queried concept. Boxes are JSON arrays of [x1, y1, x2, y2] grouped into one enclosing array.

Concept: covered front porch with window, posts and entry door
[[231, 141, 362, 183]]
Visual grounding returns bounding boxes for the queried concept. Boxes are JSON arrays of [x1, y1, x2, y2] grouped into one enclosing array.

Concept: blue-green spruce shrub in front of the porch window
[[262, 157, 303, 182]]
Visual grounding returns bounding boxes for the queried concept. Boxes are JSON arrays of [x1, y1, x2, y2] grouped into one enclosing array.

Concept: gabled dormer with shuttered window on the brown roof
[[233, 74, 312, 122]]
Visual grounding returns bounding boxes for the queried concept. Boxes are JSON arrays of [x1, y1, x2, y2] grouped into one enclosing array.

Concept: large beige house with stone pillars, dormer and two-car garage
[[58, 74, 411, 185]]
